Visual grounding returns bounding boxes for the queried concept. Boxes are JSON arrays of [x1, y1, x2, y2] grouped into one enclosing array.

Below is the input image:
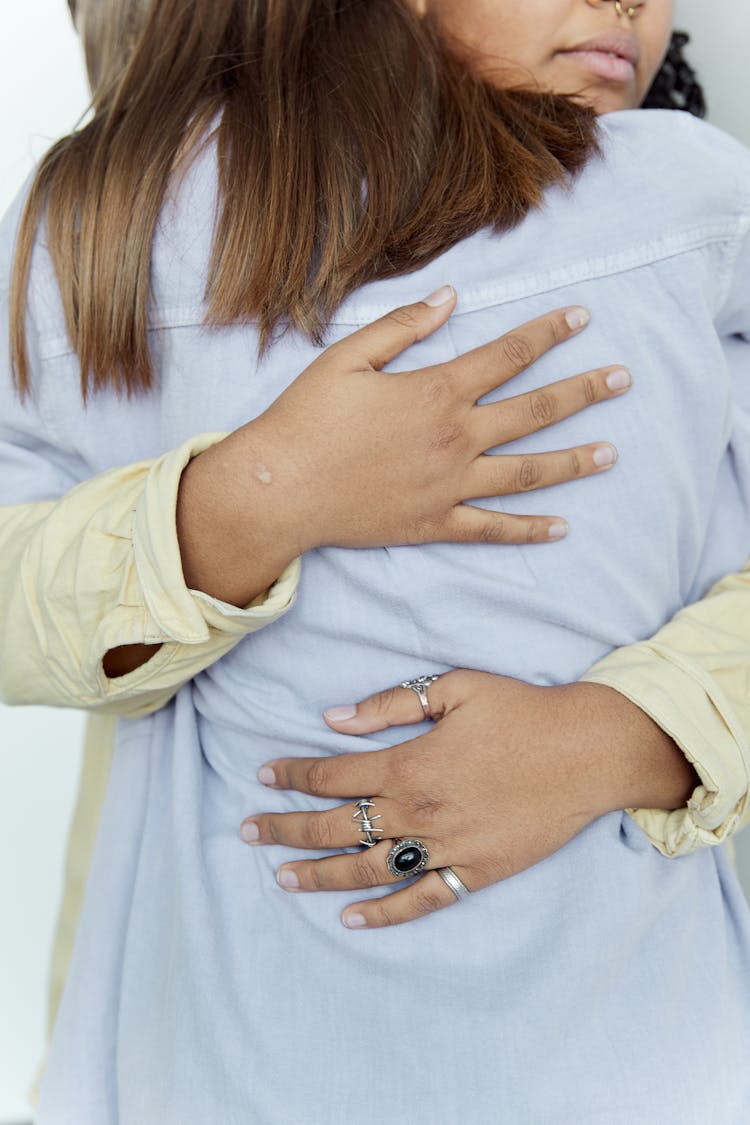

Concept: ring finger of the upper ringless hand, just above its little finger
[[464, 442, 617, 497]]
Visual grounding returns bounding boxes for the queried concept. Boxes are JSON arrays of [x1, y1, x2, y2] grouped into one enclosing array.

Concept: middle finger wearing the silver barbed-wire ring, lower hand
[[241, 798, 401, 849]]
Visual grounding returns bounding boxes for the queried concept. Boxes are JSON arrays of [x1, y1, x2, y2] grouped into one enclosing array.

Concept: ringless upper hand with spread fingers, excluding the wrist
[[247, 288, 629, 554]]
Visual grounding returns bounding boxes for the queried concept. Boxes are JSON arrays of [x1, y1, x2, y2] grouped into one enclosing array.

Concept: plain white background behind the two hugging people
[[0, 0, 750, 1122]]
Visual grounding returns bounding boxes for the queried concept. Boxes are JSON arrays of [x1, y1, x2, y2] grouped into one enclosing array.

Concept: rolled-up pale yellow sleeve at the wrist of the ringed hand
[[582, 560, 750, 856]]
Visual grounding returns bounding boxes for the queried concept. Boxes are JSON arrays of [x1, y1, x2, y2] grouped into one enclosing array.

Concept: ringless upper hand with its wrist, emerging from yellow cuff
[[174, 287, 630, 621]]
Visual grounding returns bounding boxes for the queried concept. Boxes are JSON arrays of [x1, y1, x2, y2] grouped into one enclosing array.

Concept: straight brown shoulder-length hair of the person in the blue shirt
[[11, 0, 596, 396]]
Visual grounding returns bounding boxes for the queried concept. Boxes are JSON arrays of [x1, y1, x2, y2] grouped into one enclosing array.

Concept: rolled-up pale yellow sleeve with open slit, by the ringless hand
[[0, 433, 300, 717]]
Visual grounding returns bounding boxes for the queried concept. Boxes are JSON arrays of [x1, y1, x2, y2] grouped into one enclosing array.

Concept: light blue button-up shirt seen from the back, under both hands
[[0, 111, 750, 1125]]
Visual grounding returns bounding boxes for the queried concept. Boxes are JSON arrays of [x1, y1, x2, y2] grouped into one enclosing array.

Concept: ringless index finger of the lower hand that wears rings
[[257, 747, 393, 801]]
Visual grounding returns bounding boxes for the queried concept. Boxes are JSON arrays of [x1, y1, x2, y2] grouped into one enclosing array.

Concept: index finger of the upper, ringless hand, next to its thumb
[[444, 307, 590, 402]]
